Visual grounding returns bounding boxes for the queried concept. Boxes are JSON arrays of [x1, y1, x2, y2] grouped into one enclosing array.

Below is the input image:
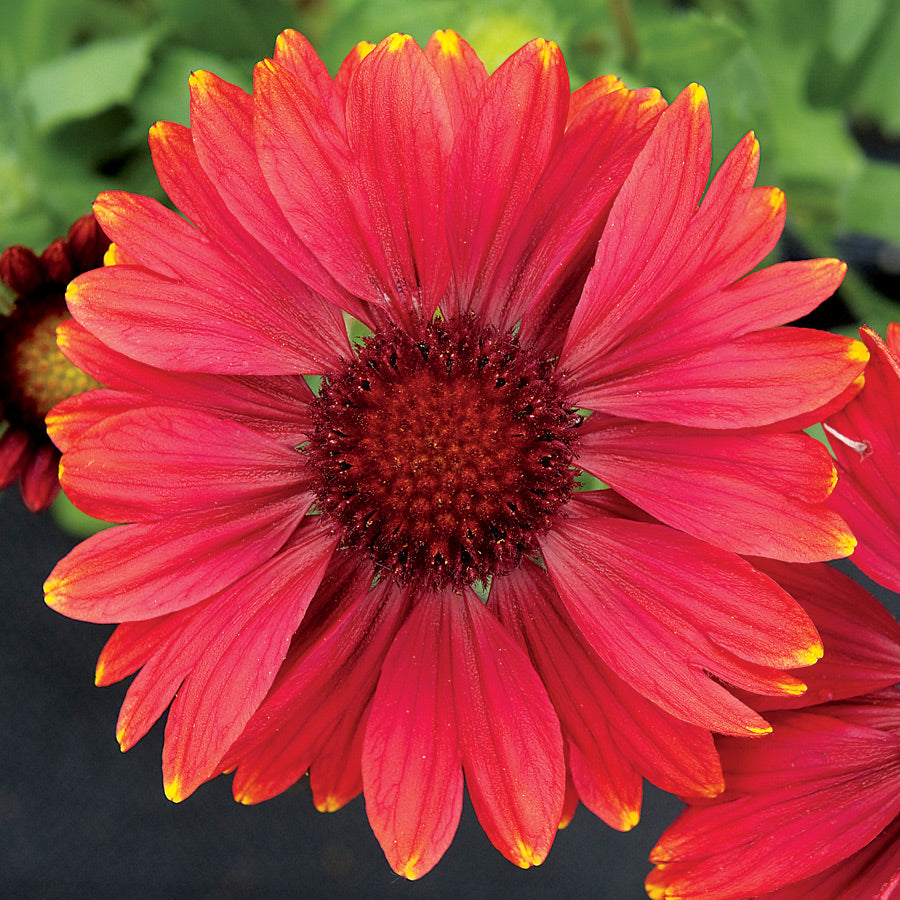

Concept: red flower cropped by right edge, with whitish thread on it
[[825, 324, 900, 591]]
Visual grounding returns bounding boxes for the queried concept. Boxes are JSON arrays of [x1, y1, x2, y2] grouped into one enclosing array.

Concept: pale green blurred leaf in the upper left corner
[[23, 30, 161, 129]]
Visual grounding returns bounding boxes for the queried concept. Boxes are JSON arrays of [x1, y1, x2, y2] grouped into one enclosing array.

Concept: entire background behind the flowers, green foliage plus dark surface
[[0, 0, 900, 900]]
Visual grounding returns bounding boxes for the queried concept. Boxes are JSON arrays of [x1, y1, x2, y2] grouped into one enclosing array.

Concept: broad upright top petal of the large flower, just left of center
[[347, 35, 453, 321]]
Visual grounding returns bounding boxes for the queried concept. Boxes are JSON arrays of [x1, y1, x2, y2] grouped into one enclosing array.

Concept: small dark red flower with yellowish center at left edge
[[0, 215, 109, 512]]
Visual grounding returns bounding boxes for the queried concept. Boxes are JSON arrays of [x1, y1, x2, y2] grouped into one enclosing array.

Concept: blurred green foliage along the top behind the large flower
[[0, 0, 900, 324]]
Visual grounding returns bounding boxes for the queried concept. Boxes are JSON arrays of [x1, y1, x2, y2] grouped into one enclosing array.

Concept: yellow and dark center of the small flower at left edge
[[0, 297, 100, 432]]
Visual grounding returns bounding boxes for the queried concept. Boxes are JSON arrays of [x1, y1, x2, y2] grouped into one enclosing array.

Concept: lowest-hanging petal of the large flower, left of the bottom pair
[[362, 595, 463, 878]]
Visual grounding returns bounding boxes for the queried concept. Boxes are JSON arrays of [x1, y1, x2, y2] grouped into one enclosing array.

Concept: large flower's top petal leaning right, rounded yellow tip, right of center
[[447, 40, 569, 318]]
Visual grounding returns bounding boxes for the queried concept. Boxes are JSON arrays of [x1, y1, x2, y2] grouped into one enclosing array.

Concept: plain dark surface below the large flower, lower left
[[0, 488, 679, 900]]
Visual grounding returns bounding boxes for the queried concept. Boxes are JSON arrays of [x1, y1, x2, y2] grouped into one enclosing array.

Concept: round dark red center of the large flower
[[305, 316, 581, 589]]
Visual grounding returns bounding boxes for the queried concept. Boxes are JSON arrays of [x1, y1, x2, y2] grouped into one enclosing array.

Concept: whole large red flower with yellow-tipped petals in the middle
[[46, 31, 866, 878]]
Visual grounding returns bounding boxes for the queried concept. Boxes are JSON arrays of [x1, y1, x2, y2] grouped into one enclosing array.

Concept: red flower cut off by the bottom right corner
[[647, 563, 900, 900]]
